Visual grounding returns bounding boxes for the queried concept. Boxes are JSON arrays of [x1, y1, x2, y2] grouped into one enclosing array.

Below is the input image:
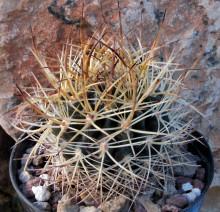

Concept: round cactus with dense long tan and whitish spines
[[15, 13, 203, 209]]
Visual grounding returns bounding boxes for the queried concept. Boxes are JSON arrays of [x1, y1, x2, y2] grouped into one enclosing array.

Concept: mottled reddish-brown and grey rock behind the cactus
[[0, 0, 220, 192]]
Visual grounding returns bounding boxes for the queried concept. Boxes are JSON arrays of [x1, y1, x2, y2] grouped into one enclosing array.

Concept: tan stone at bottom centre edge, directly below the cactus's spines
[[99, 196, 129, 212]]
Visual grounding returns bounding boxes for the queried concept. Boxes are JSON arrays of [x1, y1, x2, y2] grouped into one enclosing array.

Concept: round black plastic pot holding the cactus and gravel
[[9, 131, 214, 212]]
